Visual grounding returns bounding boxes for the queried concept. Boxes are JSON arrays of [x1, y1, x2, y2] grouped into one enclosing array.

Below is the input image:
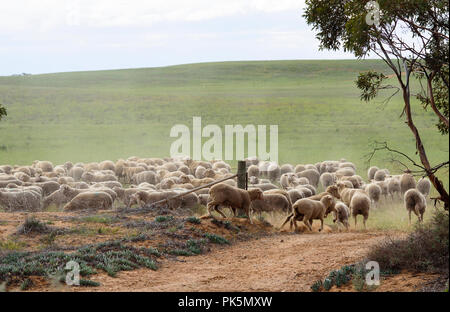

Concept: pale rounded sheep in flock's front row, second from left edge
[[63, 191, 113, 211]]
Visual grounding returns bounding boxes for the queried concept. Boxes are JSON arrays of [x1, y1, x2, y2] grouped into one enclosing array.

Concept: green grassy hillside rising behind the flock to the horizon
[[0, 60, 449, 188]]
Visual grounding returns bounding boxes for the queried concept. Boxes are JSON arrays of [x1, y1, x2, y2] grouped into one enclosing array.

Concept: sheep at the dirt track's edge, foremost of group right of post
[[280, 195, 333, 232]]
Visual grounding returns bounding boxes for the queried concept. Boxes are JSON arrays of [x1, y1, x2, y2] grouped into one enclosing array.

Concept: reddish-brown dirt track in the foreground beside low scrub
[[67, 232, 400, 291]]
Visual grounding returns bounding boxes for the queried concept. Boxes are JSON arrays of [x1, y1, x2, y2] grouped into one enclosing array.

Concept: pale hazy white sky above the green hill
[[0, 0, 353, 75]]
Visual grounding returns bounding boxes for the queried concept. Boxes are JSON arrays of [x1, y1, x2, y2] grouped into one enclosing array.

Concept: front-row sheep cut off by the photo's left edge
[[0, 189, 41, 211]]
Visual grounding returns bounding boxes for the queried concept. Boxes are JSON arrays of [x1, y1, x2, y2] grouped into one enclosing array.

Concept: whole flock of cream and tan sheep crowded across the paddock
[[0, 157, 431, 229]]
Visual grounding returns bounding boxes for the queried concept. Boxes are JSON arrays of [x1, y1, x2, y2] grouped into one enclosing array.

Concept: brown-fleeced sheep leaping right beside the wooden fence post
[[207, 183, 264, 223]]
